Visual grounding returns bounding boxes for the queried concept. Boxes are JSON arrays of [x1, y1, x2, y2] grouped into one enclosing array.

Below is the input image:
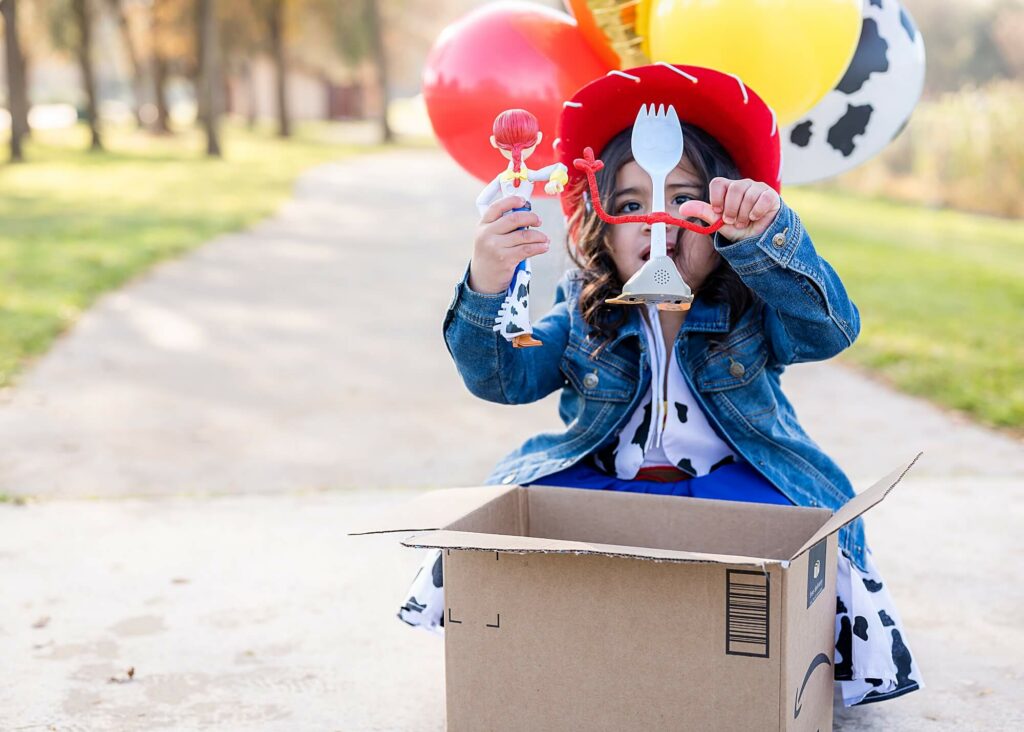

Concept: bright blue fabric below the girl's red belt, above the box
[[534, 463, 793, 506]]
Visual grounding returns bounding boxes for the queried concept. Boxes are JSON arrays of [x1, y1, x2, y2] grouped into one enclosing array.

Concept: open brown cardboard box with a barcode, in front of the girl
[[353, 458, 916, 732]]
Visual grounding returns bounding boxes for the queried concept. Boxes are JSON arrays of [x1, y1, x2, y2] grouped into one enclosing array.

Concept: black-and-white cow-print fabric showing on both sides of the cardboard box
[[398, 550, 924, 706]]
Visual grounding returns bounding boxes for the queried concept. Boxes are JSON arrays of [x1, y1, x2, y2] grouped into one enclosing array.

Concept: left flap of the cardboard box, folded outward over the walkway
[[348, 485, 519, 536]]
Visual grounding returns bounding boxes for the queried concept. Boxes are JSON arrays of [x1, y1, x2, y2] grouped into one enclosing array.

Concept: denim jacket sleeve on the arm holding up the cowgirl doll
[[443, 267, 569, 404]]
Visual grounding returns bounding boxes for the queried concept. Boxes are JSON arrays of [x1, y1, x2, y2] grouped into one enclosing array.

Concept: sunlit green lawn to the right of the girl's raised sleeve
[[786, 189, 1024, 432]]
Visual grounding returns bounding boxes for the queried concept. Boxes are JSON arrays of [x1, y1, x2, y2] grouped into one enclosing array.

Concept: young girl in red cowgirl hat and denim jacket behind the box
[[398, 64, 922, 705]]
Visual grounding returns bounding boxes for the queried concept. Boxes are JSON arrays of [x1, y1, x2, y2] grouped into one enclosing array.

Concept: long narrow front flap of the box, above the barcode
[[401, 531, 785, 567]]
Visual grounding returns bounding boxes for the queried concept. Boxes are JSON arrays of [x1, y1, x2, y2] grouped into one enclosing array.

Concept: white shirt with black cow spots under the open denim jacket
[[594, 305, 736, 480]]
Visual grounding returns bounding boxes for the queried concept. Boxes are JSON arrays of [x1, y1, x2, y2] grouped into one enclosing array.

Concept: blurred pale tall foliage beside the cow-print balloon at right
[[827, 0, 1024, 217]]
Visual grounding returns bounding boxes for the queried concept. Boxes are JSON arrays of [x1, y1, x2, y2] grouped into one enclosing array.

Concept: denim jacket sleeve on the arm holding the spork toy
[[715, 202, 860, 364]]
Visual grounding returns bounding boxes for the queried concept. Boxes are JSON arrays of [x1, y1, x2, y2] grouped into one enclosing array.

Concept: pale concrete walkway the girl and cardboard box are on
[[0, 152, 1024, 732]]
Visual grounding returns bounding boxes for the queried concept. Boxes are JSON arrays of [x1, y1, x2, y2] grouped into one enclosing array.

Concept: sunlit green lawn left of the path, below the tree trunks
[[0, 125, 355, 387]]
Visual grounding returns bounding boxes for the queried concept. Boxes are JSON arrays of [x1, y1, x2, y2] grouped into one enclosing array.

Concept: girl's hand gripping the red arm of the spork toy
[[679, 178, 782, 242]]
